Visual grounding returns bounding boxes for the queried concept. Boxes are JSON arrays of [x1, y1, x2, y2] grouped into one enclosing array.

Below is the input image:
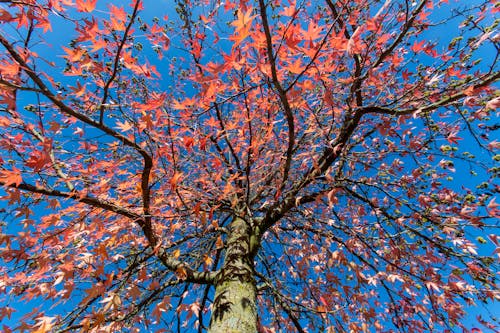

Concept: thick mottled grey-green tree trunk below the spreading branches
[[208, 218, 257, 333]]
